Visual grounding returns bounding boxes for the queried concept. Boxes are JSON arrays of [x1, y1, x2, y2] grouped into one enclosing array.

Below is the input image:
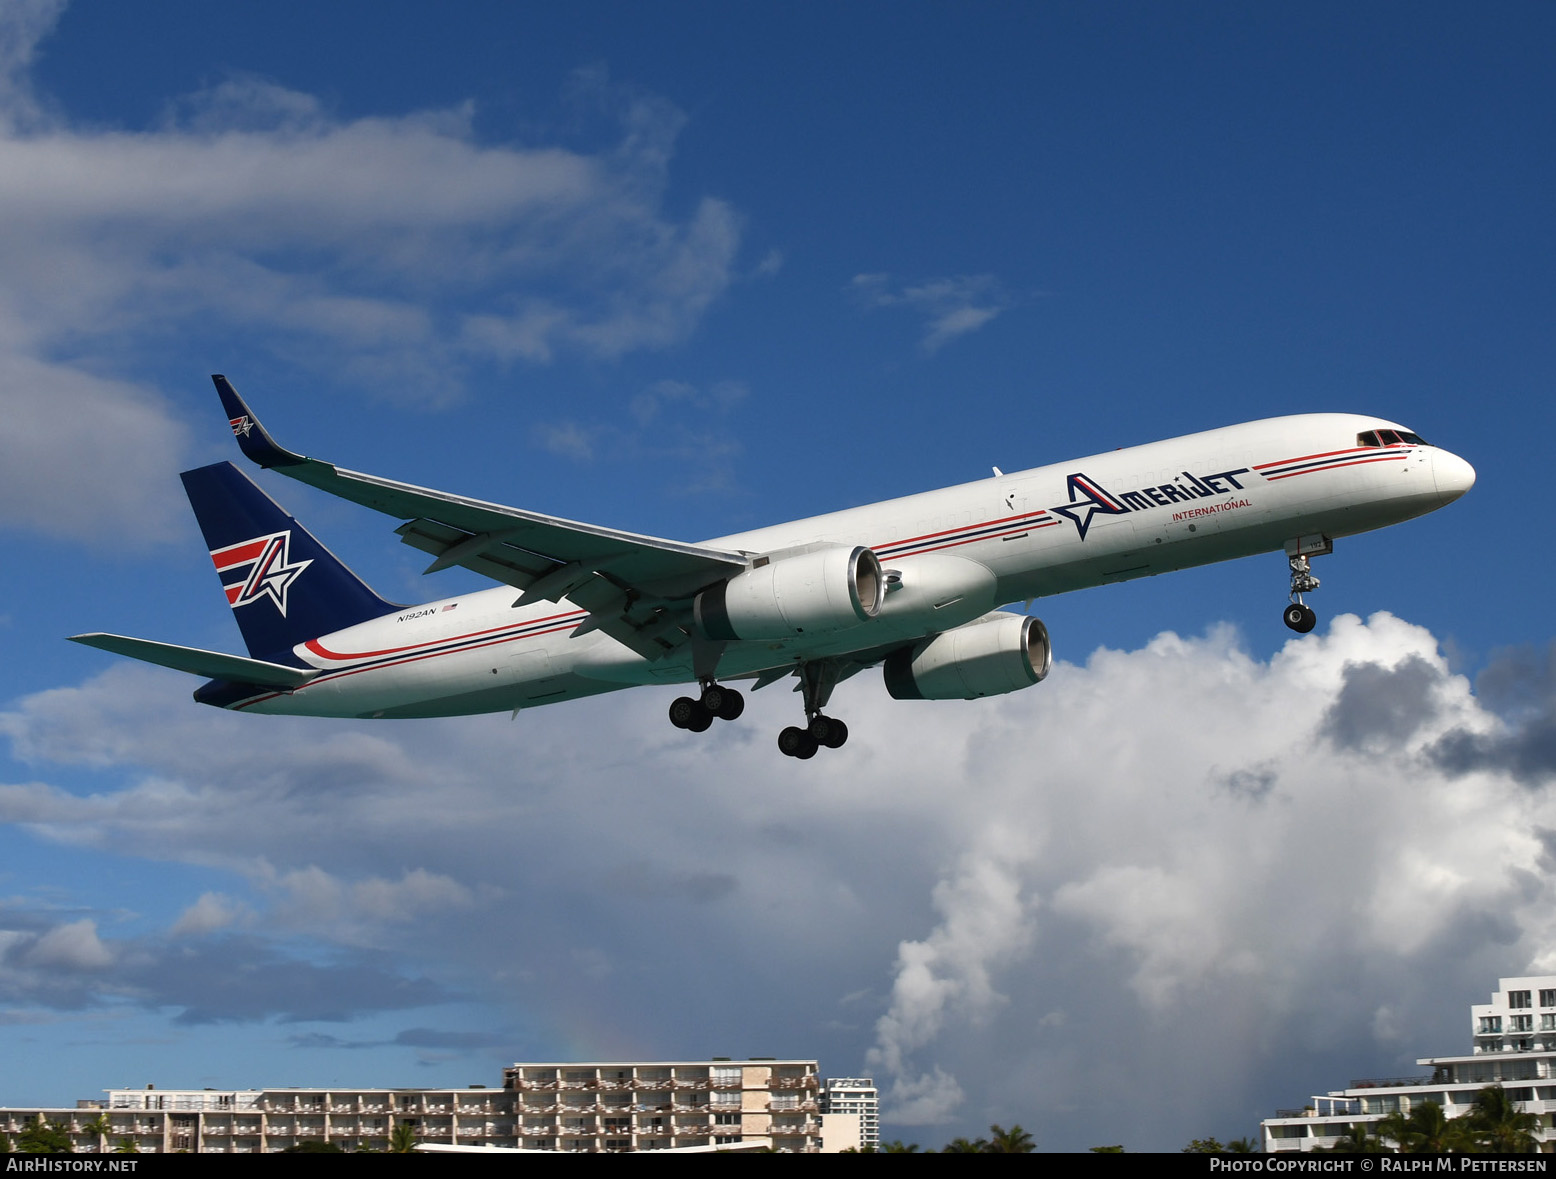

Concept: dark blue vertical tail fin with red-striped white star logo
[[179, 462, 400, 664]]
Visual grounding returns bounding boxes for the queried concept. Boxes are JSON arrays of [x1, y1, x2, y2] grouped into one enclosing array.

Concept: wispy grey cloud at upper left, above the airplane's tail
[[0, 11, 741, 540]]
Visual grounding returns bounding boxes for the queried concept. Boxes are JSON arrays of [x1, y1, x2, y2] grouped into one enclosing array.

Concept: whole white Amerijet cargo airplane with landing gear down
[[73, 376, 1475, 757]]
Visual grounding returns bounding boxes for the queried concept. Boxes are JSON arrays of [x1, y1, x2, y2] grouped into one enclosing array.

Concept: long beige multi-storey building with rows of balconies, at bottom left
[[0, 1059, 822, 1154]]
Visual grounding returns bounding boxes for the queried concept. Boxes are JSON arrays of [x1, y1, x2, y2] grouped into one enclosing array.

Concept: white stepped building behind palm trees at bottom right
[[1260, 975, 1556, 1154]]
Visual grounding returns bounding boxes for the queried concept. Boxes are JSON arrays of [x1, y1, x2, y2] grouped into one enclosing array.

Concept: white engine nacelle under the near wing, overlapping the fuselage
[[692, 546, 885, 639]]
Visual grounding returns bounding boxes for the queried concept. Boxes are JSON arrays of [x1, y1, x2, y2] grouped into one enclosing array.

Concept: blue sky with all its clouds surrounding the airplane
[[0, 0, 1556, 1149]]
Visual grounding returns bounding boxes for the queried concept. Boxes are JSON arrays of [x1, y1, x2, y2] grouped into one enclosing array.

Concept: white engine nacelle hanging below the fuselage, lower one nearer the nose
[[882, 614, 1053, 700]]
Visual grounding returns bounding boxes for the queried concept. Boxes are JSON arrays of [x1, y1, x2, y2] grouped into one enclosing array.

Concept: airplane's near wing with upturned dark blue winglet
[[212, 375, 748, 658]]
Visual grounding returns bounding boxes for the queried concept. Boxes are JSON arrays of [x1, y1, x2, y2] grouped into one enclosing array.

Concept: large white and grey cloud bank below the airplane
[[0, 614, 1556, 1149]]
